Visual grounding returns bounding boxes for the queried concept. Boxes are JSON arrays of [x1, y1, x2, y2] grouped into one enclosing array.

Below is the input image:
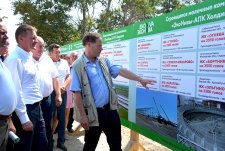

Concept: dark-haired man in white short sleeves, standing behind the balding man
[[48, 44, 71, 151]]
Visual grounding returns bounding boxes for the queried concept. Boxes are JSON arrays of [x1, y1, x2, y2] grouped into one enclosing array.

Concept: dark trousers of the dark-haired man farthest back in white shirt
[[51, 91, 67, 144]]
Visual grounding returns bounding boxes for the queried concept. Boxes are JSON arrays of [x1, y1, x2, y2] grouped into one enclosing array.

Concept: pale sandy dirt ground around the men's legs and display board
[[54, 122, 170, 151]]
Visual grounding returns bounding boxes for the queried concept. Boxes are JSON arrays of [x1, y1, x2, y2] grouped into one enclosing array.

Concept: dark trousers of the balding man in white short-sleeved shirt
[[41, 95, 53, 151]]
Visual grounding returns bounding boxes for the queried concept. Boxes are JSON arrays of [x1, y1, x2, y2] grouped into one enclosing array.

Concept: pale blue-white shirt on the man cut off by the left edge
[[0, 60, 17, 115]]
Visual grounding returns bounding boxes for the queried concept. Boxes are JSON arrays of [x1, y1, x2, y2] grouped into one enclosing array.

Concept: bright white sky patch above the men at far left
[[0, 0, 19, 52]]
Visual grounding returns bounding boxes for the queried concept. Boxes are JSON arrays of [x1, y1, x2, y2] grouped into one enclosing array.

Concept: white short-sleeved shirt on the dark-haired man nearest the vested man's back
[[54, 59, 70, 86]]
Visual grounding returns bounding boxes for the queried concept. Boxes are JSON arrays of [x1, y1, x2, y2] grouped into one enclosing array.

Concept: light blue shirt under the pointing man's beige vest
[[70, 56, 122, 107]]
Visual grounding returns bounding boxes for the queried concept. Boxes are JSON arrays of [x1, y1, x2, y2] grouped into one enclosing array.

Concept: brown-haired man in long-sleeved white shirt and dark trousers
[[5, 24, 47, 151]]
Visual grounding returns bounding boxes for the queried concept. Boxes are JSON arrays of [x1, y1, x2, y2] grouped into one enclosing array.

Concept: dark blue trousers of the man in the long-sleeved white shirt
[[12, 102, 48, 151]]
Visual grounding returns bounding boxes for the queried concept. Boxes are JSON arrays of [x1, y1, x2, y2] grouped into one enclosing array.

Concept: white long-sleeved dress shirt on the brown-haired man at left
[[5, 46, 43, 124]]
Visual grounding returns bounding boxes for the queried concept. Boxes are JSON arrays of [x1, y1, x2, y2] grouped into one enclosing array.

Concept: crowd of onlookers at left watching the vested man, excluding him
[[0, 22, 77, 151]]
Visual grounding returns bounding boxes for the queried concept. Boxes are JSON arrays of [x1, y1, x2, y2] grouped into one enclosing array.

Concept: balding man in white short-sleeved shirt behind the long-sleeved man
[[31, 36, 62, 151]]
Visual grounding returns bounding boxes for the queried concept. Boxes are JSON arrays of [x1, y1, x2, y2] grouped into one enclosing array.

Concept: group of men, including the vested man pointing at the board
[[0, 23, 155, 151]]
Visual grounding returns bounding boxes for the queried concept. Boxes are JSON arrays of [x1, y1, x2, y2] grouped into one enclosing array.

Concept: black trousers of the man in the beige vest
[[83, 109, 122, 151]]
